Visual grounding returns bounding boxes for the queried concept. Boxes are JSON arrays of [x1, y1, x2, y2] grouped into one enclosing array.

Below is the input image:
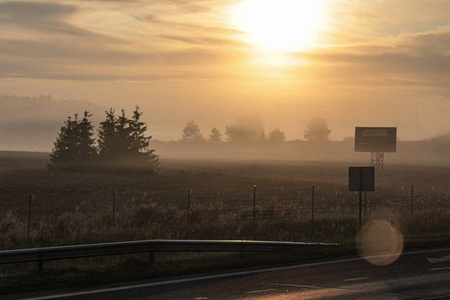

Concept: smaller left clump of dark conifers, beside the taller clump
[[50, 111, 97, 167]]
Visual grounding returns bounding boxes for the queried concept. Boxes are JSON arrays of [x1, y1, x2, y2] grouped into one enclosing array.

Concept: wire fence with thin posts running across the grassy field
[[0, 184, 449, 236]]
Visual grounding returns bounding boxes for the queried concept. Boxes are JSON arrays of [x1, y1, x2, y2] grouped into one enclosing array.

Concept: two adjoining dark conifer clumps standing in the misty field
[[49, 106, 159, 172]]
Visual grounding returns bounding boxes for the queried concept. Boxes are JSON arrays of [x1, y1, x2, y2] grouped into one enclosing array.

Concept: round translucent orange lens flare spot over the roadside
[[356, 220, 403, 266]]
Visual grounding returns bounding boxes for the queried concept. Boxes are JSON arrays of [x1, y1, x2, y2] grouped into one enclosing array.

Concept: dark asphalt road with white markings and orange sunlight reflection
[[22, 248, 450, 300]]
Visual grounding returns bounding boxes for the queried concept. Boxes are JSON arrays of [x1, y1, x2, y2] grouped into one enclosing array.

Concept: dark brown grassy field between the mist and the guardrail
[[0, 152, 450, 292]]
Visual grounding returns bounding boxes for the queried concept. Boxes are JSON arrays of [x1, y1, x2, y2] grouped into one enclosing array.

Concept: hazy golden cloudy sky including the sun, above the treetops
[[0, 0, 450, 145]]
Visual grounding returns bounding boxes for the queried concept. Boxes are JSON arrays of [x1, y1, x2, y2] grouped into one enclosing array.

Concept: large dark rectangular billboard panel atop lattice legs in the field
[[355, 127, 397, 152]]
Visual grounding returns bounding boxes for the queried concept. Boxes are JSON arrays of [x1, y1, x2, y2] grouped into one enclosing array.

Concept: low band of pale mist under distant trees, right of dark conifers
[[152, 138, 450, 167]]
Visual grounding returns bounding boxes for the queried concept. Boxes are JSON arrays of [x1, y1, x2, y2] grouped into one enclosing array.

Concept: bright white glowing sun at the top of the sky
[[234, 0, 322, 51]]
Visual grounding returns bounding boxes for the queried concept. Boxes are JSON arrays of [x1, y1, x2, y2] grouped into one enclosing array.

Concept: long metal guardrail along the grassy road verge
[[0, 240, 337, 271]]
